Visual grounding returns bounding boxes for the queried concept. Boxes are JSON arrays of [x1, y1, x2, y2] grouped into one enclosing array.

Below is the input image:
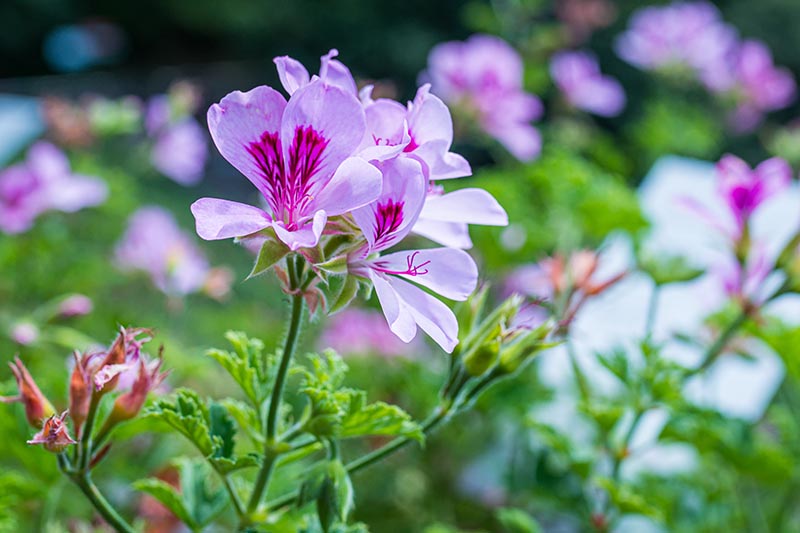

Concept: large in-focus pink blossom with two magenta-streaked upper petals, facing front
[[192, 69, 381, 250]]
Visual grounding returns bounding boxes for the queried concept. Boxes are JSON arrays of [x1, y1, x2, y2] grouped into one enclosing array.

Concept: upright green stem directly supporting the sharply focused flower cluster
[[247, 290, 303, 514]]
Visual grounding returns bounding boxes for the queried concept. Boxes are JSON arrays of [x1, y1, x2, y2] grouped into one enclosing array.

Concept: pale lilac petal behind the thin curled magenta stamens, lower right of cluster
[[373, 248, 478, 300]]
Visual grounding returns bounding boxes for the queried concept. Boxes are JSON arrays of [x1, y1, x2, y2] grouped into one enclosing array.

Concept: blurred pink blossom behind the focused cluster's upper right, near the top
[[423, 35, 543, 161]]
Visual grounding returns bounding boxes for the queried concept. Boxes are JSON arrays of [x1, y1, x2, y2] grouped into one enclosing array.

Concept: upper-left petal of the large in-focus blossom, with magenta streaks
[[208, 86, 286, 197]]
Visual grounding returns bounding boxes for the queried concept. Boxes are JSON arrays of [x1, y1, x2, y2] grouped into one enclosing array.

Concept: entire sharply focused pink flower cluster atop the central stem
[[192, 50, 507, 351]]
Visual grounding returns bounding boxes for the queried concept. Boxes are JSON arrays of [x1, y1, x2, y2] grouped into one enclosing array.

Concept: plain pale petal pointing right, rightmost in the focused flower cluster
[[419, 188, 508, 226]]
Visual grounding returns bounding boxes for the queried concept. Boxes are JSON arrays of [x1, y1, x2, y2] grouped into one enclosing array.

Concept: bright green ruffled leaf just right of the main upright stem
[[300, 350, 424, 442]]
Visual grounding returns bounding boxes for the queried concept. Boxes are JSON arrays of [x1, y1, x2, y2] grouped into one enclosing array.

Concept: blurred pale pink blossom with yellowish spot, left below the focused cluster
[[115, 206, 225, 296]]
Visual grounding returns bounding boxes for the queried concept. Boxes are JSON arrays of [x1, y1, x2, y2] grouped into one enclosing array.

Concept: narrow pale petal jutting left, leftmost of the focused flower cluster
[[191, 198, 272, 241]]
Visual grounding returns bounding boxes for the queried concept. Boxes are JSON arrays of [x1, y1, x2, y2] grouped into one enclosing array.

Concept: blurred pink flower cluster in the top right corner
[[616, 2, 796, 131]]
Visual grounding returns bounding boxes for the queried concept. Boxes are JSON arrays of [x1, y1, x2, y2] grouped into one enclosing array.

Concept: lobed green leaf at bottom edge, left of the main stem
[[133, 460, 227, 531]]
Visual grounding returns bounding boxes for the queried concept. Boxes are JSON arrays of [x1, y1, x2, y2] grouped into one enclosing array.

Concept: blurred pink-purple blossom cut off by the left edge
[[0, 141, 108, 234]]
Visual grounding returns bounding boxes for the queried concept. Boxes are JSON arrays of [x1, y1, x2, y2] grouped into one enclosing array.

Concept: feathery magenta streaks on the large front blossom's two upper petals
[[247, 126, 328, 231]]
